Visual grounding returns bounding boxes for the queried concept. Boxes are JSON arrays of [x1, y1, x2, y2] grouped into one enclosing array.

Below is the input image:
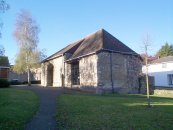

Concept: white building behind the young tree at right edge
[[142, 56, 173, 87]]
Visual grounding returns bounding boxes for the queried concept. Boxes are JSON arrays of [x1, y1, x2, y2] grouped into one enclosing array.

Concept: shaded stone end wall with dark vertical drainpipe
[[97, 52, 142, 93]]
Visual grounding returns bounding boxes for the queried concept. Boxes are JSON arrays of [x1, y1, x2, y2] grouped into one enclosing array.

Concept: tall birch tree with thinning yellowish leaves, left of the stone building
[[14, 10, 42, 86]]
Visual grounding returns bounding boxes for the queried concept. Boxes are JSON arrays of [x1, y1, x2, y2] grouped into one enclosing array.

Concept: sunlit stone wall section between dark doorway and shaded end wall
[[79, 55, 98, 87]]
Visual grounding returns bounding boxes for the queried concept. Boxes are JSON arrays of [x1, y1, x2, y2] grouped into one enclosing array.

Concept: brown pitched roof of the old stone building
[[43, 29, 138, 62]]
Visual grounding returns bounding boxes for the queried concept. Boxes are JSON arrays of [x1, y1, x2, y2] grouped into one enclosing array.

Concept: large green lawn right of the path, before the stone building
[[56, 94, 173, 130]]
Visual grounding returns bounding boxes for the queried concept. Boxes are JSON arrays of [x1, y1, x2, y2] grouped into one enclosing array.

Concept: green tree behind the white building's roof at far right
[[156, 42, 173, 57]]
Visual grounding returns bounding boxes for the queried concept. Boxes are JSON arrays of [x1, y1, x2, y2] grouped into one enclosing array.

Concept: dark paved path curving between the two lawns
[[22, 86, 62, 130]]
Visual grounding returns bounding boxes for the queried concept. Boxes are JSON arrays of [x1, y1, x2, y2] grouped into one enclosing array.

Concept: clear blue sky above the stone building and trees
[[0, 0, 173, 64]]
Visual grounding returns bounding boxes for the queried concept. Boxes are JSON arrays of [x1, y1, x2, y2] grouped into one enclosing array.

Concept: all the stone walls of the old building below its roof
[[41, 52, 142, 93]]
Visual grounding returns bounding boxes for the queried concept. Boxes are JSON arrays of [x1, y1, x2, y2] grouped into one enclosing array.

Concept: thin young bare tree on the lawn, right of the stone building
[[143, 34, 151, 107]]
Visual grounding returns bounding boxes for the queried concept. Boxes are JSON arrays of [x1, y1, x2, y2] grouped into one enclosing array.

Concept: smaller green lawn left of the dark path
[[0, 88, 38, 130]]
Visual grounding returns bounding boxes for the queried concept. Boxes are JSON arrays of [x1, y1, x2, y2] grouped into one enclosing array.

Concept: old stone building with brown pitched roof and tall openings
[[41, 29, 142, 93]]
